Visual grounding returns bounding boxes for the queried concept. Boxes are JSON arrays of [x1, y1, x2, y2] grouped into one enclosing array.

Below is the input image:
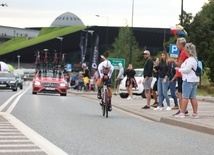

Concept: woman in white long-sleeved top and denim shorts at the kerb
[[175, 43, 199, 118]]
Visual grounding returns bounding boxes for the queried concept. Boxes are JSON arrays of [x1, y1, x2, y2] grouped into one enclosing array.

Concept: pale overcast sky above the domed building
[[0, 0, 208, 28]]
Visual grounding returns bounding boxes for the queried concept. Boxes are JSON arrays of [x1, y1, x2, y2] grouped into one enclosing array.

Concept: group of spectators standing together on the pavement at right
[[142, 37, 199, 118]]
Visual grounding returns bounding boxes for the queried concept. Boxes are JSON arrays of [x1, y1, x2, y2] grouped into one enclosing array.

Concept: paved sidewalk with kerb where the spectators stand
[[69, 90, 214, 135]]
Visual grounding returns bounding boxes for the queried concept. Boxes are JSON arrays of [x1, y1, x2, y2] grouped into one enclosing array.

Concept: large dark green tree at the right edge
[[189, 0, 214, 83]]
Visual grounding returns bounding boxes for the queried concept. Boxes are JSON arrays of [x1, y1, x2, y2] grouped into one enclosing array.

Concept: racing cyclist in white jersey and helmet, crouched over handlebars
[[97, 60, 114, 111]]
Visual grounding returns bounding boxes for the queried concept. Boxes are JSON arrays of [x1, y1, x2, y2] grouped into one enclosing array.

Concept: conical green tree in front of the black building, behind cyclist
[[108, 26, 143, 68]]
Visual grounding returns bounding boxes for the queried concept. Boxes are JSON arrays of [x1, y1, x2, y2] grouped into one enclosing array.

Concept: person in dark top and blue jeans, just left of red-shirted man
[[169, 63, 179, 109]]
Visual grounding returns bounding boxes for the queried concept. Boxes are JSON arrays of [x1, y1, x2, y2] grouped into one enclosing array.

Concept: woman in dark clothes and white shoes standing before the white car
[[124, 64, 137, 100]]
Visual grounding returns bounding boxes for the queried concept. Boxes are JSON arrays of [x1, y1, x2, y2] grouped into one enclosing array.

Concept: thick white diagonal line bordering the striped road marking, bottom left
[[3, 113, 68, 155]]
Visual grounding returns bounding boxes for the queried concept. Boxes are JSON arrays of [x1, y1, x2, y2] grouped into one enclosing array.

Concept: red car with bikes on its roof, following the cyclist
[[32, 70, 68, 96]]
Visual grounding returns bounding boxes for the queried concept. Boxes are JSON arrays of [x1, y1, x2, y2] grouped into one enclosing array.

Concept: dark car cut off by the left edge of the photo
[[0, 72, 18, 91]]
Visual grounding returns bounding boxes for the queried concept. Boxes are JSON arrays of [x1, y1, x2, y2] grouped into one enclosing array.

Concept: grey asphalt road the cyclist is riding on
[[0, 81, 214, 155]]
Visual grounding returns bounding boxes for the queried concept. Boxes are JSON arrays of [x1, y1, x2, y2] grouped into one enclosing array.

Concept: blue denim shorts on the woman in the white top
[[182, 81, 198, 99]]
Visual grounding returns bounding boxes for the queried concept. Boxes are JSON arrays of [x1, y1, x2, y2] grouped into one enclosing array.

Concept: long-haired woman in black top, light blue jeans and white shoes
[[154, 52, 171, 110]]
